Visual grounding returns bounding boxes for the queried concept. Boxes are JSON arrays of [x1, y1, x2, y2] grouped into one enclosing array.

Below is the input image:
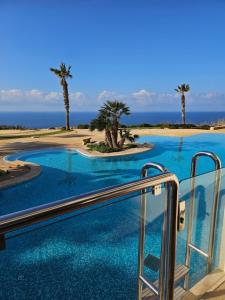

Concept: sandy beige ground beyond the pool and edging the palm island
[[0, 129, 225, 188]]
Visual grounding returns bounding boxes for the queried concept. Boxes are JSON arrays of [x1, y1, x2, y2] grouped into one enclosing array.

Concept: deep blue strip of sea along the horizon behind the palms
[[0, 111, 225, 128]]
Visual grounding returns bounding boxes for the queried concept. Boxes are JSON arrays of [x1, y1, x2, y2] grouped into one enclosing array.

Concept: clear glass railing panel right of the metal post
[[177, 169, 225, 287]]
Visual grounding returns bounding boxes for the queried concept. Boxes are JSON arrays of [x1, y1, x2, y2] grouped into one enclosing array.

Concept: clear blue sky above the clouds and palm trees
[[0, 0, 225, 111]]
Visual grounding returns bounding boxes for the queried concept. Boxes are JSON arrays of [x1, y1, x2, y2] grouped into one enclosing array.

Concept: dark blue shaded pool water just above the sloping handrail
[[0, 167, 128, 215]]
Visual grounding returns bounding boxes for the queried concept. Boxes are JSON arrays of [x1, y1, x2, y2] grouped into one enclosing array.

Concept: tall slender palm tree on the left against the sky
[[50, 63, 72, 130]]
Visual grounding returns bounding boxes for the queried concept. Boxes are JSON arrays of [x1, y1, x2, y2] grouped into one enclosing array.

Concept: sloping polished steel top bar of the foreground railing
[[0, 173, 177, 234]]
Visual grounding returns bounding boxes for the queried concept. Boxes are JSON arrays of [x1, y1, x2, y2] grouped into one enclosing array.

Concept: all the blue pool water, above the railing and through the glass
[[0, 134, 225, 299]]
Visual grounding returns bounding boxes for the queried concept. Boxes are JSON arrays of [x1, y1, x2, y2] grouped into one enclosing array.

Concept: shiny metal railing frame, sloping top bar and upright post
[[0, 172, 179, 300]]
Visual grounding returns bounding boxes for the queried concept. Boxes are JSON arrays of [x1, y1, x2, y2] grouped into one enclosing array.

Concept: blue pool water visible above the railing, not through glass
[[0, 134, 225, 214]]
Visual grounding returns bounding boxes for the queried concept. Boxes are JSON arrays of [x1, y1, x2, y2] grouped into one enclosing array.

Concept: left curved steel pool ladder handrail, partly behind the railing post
[[138, 162, 176, 300]]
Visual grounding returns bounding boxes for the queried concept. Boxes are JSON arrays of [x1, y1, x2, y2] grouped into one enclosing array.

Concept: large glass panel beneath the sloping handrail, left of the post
[[0, 184, 169, 300]]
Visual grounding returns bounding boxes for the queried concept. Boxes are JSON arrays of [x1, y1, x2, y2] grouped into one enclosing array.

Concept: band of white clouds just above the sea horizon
[[0, 89, 225, 111]]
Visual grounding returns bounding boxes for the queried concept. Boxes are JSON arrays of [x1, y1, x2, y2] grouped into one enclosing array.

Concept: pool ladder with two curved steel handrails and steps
[[138, 151, 221, 300]]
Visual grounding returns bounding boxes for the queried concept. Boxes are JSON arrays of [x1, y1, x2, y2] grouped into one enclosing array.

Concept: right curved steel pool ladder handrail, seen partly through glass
[[184, 151, 222, 289]]
